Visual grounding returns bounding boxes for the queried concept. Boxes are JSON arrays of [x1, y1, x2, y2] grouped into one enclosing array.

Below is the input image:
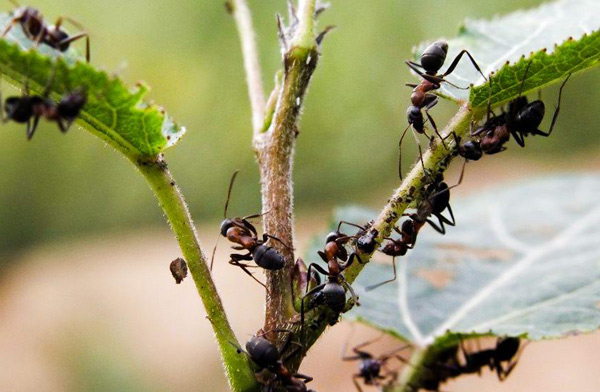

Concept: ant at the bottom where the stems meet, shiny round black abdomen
[[232, 330, 314, 392]]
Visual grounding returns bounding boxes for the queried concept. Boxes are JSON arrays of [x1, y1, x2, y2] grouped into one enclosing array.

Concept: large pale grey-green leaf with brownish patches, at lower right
[[336, 175, 600, 346]]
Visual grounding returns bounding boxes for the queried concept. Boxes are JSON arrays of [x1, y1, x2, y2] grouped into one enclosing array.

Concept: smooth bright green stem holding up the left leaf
[[138, 156, 259, 392]]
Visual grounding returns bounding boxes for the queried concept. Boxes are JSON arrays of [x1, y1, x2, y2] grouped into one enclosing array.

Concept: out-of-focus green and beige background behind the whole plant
[[0, 0, 600, 392]]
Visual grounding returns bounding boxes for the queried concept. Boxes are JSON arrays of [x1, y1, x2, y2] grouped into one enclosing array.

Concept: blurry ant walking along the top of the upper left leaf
[[2, 0, 90, 63]]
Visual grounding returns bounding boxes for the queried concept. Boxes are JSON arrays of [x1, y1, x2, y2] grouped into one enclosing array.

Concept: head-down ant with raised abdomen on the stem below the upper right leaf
[[398, 41, 487, 178]]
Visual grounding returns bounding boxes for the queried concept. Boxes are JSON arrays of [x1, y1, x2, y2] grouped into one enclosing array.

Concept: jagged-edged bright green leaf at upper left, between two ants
[[0, 14, 185, 159]]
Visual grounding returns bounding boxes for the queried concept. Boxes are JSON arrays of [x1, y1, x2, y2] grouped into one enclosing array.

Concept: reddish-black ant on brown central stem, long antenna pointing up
[[210, 171, 288, 288]]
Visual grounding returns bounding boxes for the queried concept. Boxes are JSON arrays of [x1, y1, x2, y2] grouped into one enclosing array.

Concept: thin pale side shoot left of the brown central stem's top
[[230, 0, 265, 135]]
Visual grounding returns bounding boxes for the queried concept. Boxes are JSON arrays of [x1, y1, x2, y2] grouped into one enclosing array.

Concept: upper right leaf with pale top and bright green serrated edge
[[414, 0, 600, 107]]
